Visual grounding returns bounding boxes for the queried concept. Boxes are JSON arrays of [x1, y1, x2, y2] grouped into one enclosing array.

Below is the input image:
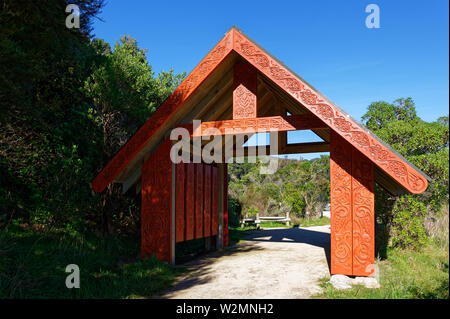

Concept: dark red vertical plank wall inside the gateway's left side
[[175, 163, 219, 243]]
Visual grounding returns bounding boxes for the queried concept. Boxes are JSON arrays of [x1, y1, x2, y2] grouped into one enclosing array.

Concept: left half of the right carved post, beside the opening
[[330, 132, 353, 275]]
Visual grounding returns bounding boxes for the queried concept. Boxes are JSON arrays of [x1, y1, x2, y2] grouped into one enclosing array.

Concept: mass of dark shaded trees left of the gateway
[[0, 0, 184, 233]]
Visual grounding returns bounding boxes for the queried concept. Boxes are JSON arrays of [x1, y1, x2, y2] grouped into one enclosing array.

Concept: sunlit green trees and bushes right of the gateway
[[362, 98, 449, 251]]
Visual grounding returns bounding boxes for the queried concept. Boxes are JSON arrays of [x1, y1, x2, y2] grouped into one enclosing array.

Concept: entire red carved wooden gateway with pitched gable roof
[[91, 27, 429, 276]]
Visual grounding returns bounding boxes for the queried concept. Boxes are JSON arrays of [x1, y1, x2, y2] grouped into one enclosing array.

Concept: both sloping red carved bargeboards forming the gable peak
[[91, 27, 429, 194]]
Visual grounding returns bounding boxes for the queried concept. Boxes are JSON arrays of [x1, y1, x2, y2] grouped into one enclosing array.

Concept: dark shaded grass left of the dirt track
[[0, 226, 183, 298]]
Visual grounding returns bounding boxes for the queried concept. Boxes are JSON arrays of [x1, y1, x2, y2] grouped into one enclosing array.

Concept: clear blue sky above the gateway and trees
[[93, 0, 449, 157]]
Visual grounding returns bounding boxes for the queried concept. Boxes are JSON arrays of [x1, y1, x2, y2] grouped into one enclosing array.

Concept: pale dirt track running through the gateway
[[160, 225, 330, 299]]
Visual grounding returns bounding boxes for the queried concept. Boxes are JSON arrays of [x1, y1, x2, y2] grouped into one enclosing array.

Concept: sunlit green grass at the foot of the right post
[[315, 244, 449, 299]]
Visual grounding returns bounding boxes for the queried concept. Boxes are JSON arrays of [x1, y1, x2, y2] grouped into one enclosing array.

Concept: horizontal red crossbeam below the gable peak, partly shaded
[[192, 114, 327, 137]]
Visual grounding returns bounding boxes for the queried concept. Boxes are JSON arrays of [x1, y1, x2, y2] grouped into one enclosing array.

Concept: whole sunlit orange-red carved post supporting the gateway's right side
[[330, 132, 375, 276]]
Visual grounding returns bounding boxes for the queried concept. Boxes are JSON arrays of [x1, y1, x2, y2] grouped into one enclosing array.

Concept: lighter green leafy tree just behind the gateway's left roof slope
[[84, 36, 184, 159]]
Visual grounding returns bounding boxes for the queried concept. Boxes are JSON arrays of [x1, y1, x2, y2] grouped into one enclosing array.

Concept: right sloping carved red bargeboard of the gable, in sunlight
[[232, 29, 428, 194]]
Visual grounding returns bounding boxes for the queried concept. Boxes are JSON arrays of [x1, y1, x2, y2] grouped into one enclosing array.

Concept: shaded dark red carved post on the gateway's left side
[[141, 139, 172, 262]]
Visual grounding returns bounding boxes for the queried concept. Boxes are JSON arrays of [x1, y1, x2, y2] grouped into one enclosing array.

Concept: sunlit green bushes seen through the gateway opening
[[229, 156, 330, 222]]
